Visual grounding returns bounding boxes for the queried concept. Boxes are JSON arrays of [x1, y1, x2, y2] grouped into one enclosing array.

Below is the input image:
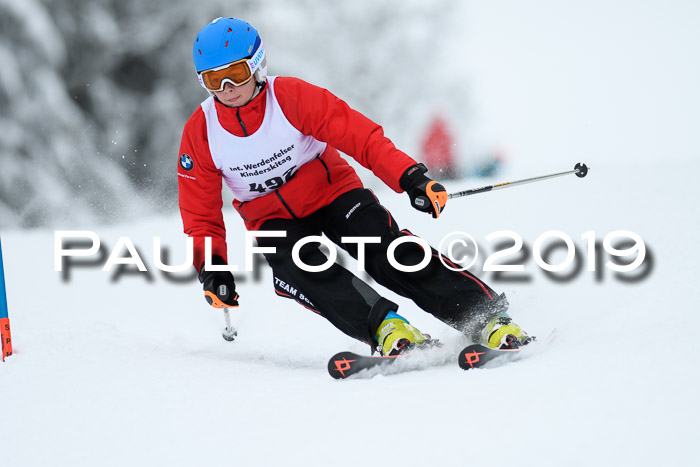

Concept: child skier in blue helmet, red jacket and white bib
[[178, 18, 531, 355]]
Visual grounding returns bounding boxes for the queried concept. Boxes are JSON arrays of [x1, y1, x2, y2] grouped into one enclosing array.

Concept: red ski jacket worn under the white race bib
[[178, 77, 416, 271]]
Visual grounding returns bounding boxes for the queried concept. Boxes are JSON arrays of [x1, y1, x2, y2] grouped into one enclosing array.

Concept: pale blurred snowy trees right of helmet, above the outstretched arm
[[251, 0, 466, 157]]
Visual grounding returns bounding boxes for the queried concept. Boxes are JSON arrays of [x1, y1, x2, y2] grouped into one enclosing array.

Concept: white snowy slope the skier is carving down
[[0, 158, 700, 467]]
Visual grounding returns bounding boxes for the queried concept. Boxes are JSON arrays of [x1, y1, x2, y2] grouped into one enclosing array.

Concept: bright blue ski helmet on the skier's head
[[192, 18, 267, 82]]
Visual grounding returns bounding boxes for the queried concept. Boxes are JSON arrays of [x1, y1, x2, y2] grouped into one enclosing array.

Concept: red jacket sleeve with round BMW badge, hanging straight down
[[177, 107, 227, 271]]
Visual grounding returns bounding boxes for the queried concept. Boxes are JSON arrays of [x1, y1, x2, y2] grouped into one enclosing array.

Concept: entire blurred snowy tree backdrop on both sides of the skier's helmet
[[0, 0, 470, 228]]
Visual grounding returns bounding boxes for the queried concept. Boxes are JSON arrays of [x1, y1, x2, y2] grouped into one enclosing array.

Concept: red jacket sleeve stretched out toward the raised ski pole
[[274, 77, 416, 193]]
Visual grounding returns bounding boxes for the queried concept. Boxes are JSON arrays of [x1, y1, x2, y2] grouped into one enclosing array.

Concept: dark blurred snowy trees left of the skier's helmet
[[0, 0, 226, 227]]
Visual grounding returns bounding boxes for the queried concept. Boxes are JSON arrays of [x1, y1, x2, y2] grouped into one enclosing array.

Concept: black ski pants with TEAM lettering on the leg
[[257, 189, 507, 346]]
